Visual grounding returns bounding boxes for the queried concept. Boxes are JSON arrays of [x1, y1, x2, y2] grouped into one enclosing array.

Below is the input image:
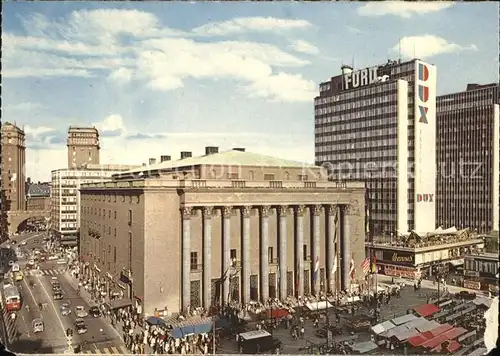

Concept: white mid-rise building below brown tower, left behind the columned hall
[[50, 164, 136, 245]]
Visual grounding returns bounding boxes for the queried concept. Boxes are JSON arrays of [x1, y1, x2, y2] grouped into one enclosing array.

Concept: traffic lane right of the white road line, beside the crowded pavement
[[52, 275, 122, 347]]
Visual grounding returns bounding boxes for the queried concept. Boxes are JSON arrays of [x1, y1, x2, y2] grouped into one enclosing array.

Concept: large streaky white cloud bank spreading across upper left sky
[[2, 10, 317, 101]]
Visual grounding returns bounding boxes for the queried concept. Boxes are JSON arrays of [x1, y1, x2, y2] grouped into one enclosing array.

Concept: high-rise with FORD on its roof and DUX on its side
[[314, 59, 436, 235]]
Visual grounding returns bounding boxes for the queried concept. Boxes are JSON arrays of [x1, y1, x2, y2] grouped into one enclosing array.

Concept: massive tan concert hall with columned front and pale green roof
[[80, 147, 365, 314]]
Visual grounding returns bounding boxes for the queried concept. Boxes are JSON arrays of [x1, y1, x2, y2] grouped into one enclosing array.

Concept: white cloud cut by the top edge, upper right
[[357, 1, 454, 18]]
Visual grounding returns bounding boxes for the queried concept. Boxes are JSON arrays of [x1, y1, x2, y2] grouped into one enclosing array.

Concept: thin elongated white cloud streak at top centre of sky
[[193, 17, 312, 36]]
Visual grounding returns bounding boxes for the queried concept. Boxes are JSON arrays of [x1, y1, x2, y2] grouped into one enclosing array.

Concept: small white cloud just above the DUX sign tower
[[391, 35, 477, 58]]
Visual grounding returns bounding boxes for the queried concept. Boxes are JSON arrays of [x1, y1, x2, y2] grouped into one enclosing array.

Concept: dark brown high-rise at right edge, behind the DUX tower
[[436, 84, 500, 233]]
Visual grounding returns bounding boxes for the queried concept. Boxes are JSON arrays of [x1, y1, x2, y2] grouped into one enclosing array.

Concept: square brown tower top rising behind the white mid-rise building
[[67, 126, 100, 169]]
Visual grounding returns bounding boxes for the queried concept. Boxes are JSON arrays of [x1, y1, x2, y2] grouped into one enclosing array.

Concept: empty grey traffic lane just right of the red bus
[[26, 270, 71, 351]]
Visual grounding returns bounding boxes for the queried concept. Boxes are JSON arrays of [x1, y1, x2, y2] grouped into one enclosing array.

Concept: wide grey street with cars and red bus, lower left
[[4, 236, 128, 354]]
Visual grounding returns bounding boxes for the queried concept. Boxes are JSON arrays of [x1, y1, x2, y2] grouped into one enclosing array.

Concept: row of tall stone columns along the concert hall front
[[181, 204, 351, 310]]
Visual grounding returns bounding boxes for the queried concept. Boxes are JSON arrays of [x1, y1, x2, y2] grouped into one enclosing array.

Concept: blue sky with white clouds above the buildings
[[2, 2, 498, 181]]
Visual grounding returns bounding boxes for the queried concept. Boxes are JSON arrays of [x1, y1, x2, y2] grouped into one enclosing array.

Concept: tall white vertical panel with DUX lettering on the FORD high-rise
[[414, 60, 436, 232]]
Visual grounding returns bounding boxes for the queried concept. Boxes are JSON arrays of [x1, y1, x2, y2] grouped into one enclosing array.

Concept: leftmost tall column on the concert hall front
[[182, 207, 192, 310]]
